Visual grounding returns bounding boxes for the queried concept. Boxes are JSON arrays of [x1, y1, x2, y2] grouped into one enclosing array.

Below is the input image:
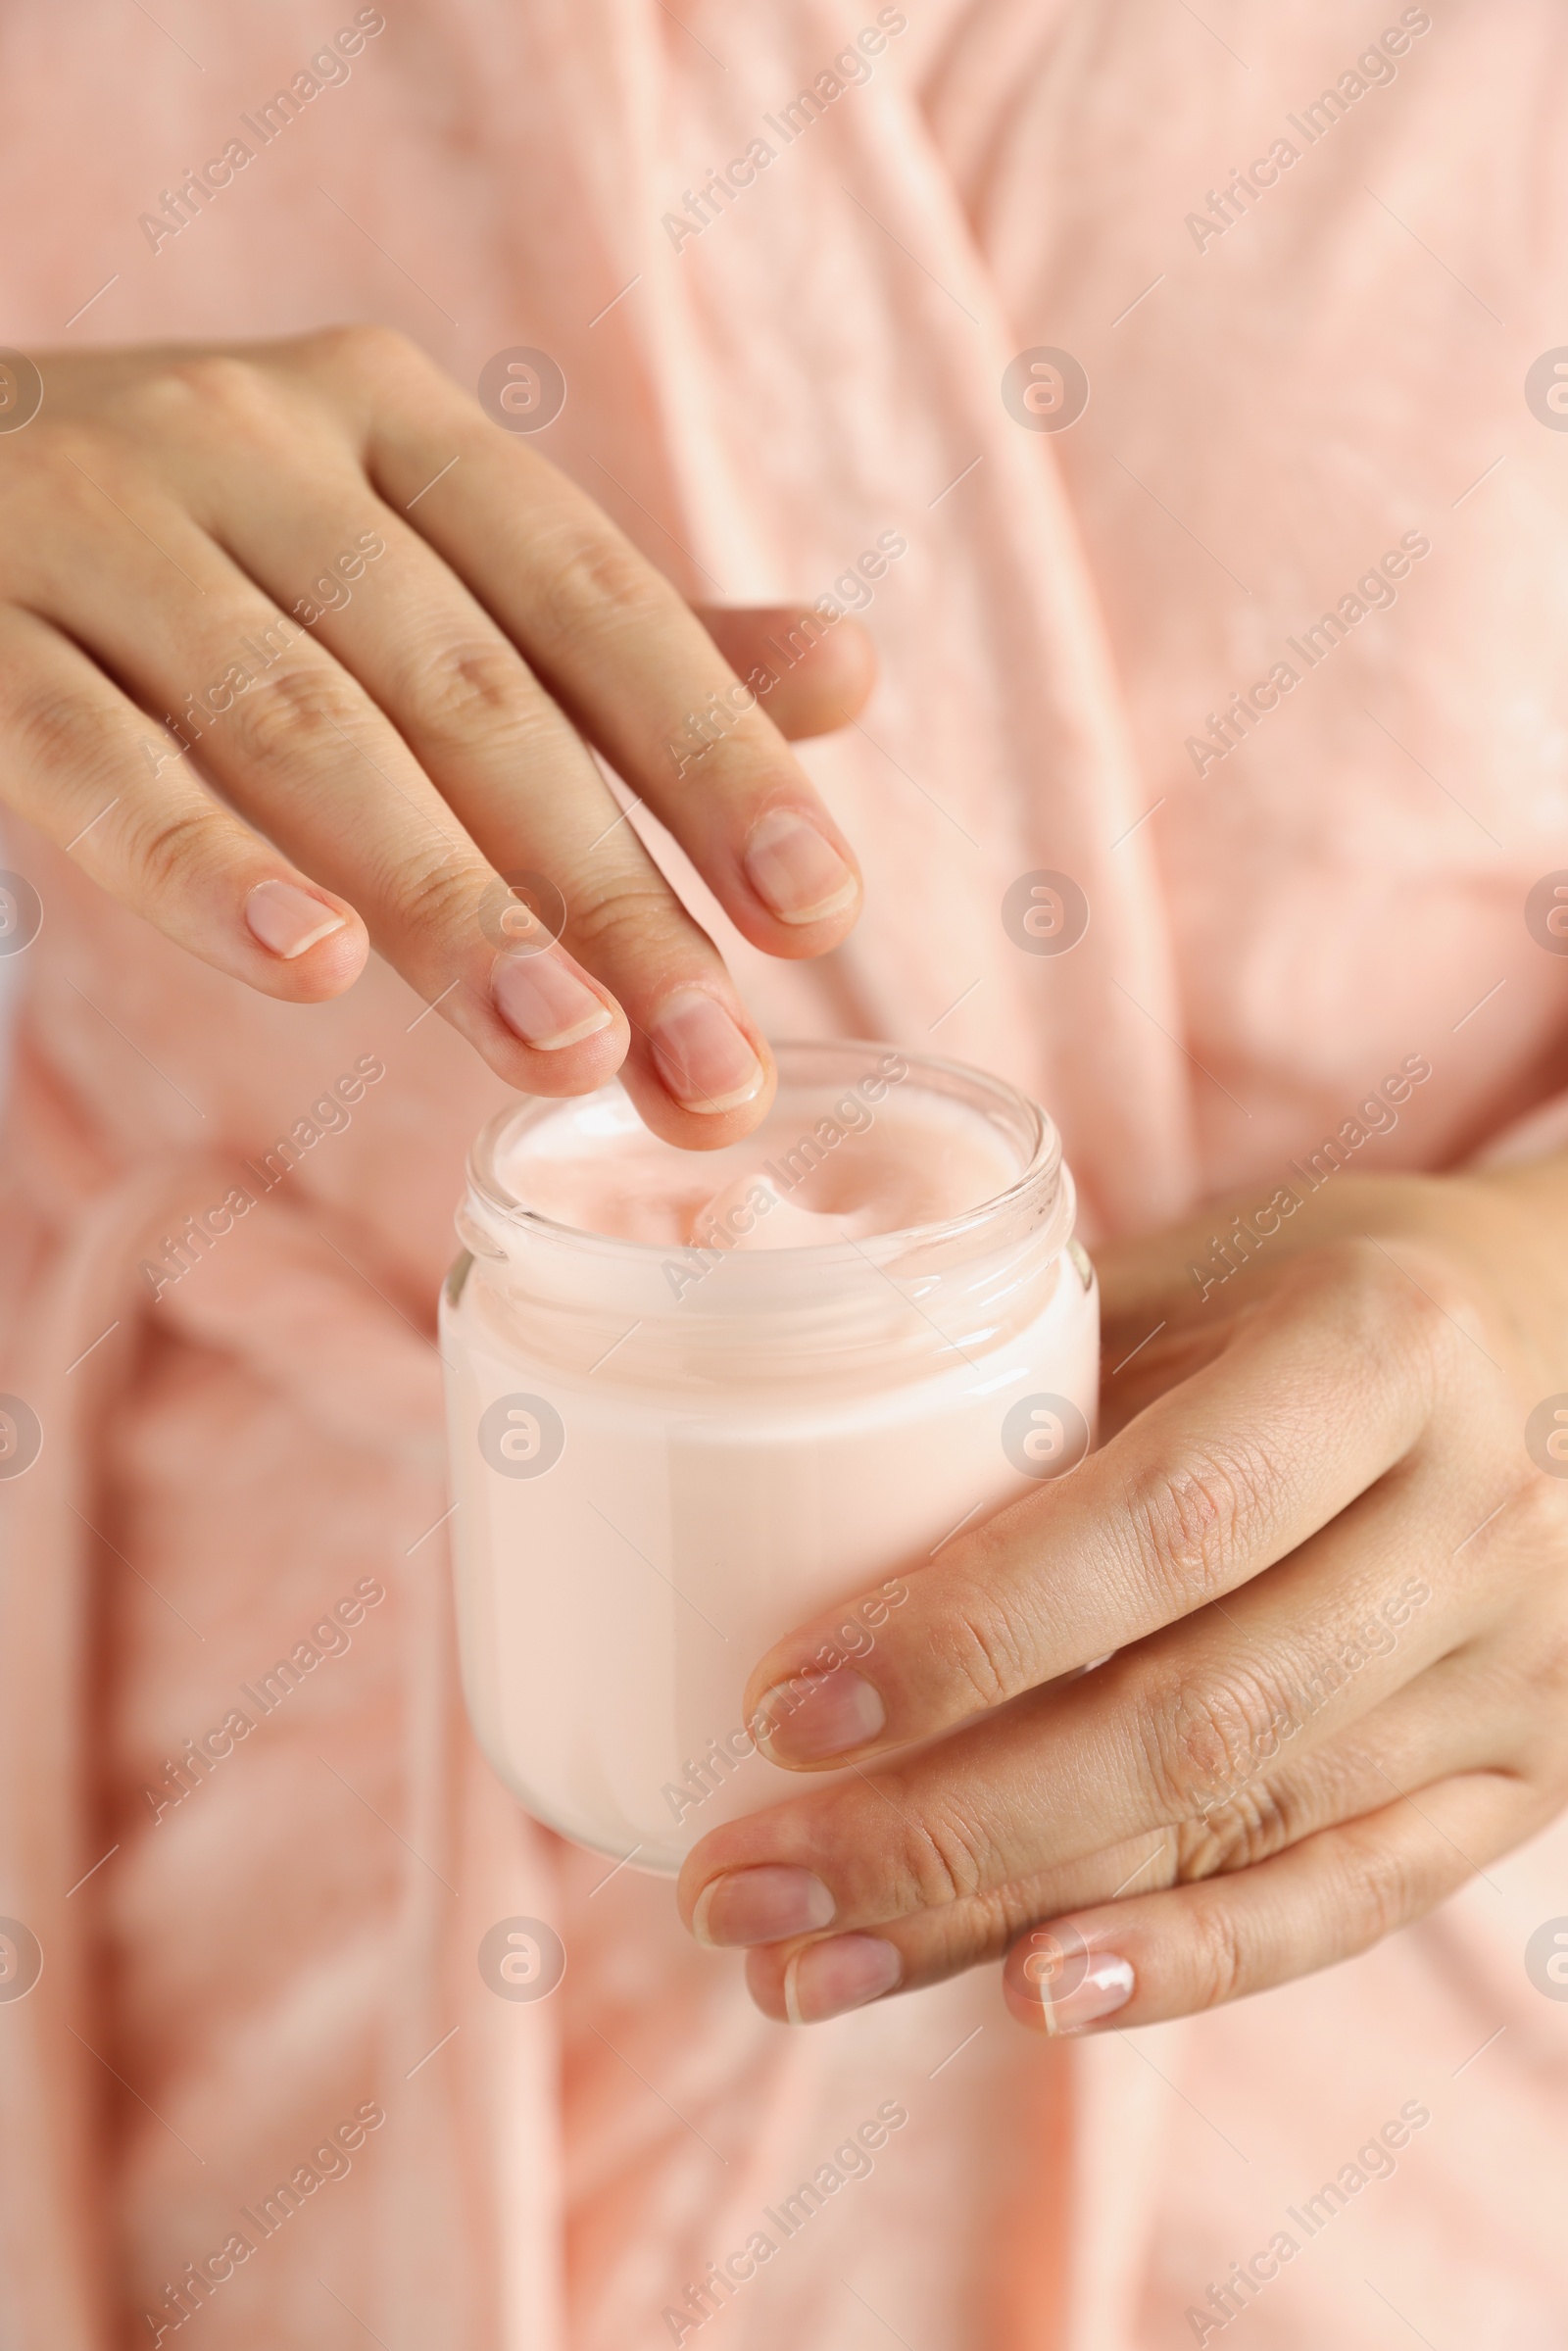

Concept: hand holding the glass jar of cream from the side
[[679, 1161, 1568, 2032]]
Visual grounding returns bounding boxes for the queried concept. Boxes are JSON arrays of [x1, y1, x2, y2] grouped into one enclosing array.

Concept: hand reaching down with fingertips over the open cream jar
[[0, 326, 870, 1148]]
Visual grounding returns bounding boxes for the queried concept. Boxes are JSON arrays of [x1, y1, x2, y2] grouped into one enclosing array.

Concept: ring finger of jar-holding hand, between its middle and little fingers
[[738, 1652, 1533, 2025]]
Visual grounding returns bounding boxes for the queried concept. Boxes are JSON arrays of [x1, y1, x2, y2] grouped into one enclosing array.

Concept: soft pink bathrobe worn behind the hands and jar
[[0, 0, 1568, 2351]]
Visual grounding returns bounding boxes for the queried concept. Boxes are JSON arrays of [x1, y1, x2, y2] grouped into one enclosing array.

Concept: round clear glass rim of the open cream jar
[[467, 1037, 1074, 1274]]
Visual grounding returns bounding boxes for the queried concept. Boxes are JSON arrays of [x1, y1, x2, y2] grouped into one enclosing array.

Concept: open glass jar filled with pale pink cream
[[440, 1044, 1098, 1872]]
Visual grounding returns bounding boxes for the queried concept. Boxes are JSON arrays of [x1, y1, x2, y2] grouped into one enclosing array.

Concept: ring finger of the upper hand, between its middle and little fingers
[[18, 472, 627, 1094]]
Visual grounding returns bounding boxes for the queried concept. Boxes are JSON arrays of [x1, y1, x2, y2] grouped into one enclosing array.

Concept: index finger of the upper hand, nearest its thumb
[[308, 331, 860, 956]]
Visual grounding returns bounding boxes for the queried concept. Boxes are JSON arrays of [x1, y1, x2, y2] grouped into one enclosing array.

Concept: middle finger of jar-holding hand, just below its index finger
[[682, 1477, 1484, 1942]]
